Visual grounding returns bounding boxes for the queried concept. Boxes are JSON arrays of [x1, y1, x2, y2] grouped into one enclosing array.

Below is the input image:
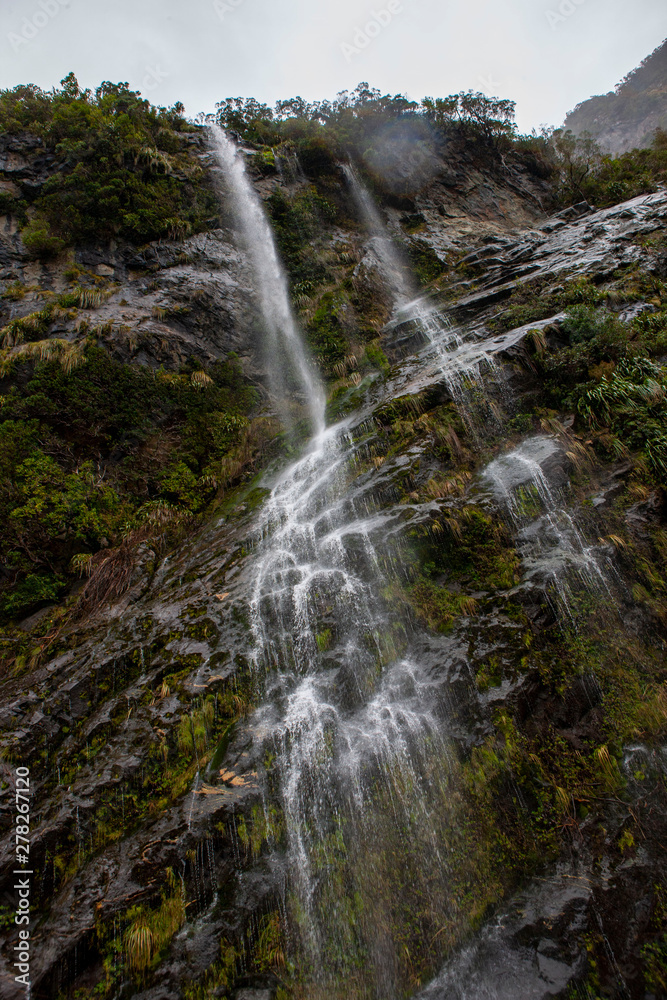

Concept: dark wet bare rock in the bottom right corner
[[417, 748, 665, 1000]]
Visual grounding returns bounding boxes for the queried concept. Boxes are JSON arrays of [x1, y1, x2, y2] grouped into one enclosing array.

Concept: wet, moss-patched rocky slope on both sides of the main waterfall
[[0, 99, 667, 1000]]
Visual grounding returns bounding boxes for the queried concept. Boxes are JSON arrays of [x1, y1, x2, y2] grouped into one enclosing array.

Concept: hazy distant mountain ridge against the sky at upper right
[[564, 39, 667, 153]]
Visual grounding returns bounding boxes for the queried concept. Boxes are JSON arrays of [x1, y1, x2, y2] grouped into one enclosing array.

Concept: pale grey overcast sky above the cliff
[[0, 0, 667, 131]]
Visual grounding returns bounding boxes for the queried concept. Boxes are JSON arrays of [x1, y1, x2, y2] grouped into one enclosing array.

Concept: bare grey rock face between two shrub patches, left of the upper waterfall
[[2, 230, 265, 379]]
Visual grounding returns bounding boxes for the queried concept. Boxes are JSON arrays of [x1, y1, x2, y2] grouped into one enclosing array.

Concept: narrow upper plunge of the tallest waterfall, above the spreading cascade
[[211, 125, 325, 434]]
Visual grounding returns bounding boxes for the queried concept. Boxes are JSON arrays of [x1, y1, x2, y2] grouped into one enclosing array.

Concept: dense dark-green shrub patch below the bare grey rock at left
[[0, 342, 256, 616]]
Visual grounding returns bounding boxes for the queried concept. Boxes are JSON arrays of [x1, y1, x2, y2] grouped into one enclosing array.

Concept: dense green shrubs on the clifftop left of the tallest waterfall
[[0, 73, 218, 258]]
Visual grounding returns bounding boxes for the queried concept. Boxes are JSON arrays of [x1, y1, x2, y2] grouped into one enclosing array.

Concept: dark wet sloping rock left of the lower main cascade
[[0, 508, 266, 998]]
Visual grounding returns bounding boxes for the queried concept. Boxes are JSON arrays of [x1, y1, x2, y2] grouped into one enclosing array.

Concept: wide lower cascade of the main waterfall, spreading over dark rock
[[252, 425, 456, 976]]
